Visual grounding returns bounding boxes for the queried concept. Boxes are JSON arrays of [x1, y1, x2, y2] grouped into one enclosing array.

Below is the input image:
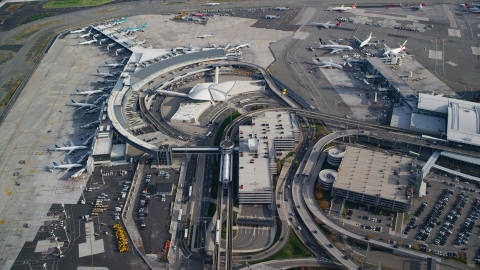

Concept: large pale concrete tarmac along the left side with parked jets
[[0, 30, 122, 266]]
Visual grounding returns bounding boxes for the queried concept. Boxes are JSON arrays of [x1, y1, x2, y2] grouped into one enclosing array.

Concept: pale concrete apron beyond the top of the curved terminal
[[122, 15, 293, 68]]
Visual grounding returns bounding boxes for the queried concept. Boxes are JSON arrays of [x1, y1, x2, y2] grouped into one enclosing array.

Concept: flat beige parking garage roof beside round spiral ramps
[[333, 146, 413, 203]]
